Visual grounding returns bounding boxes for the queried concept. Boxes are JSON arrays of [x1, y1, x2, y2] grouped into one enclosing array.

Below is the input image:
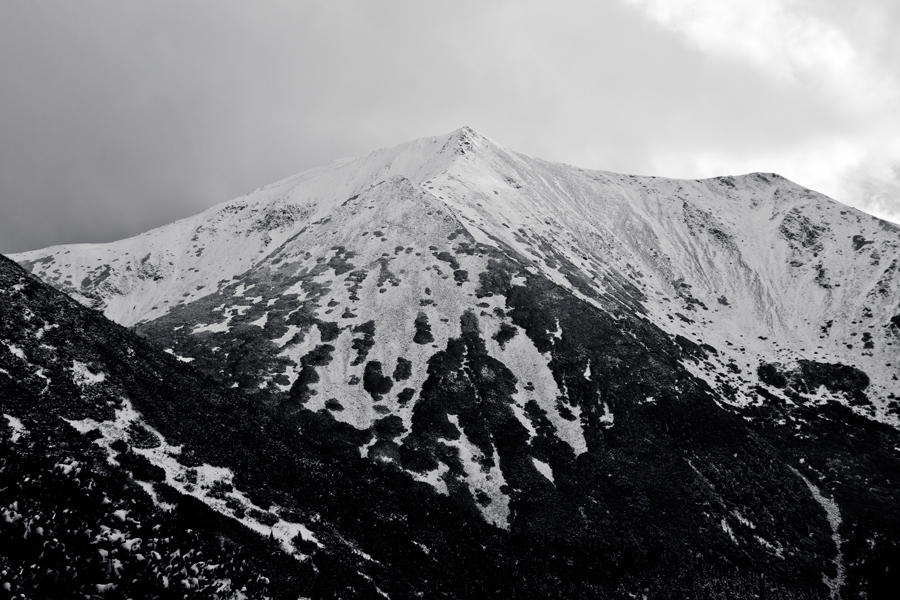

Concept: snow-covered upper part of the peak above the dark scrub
[[13, 128, 900, 423]]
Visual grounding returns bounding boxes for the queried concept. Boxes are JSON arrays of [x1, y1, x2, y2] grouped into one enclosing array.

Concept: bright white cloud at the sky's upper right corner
[[625, 0, 900, 221]]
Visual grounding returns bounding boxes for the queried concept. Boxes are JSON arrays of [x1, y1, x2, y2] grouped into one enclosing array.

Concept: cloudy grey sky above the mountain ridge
[[0, 0, 900, 253]]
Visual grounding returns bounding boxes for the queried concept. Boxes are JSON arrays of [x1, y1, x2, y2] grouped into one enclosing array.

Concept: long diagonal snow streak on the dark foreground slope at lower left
[[68, 398, 321, 559]]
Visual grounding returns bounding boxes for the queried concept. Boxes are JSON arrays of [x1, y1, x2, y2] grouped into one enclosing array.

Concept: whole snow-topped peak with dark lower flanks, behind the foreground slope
[[11, 128, 900, 598]]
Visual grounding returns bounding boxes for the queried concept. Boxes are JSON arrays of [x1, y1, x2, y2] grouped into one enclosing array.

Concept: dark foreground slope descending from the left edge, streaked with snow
[[0, 257, 542, 598]]
